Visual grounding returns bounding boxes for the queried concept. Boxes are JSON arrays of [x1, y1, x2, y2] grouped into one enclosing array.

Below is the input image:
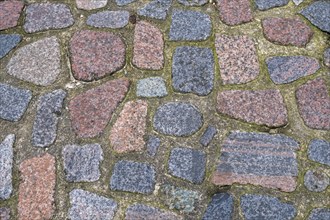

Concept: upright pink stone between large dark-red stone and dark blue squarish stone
[[132, 21, 164, 70]]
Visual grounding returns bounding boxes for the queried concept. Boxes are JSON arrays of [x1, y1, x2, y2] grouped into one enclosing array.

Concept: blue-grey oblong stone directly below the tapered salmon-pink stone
[[110, 160, 156, 194]]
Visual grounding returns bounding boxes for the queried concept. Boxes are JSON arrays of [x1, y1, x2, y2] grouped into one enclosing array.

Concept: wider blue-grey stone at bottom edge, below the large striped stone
[[241, 194, 297, 220]]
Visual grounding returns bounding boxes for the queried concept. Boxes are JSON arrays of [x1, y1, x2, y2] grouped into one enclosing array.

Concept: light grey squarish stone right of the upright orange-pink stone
[[62, 144, 103, 182]]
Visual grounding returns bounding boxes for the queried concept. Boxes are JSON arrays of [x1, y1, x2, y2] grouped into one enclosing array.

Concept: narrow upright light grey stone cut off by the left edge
[[0, 134, 15, 200]]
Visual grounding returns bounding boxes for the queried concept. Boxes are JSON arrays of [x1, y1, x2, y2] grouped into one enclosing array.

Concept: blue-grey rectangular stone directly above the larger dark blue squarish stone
[[169, 10, 212, 41]]
